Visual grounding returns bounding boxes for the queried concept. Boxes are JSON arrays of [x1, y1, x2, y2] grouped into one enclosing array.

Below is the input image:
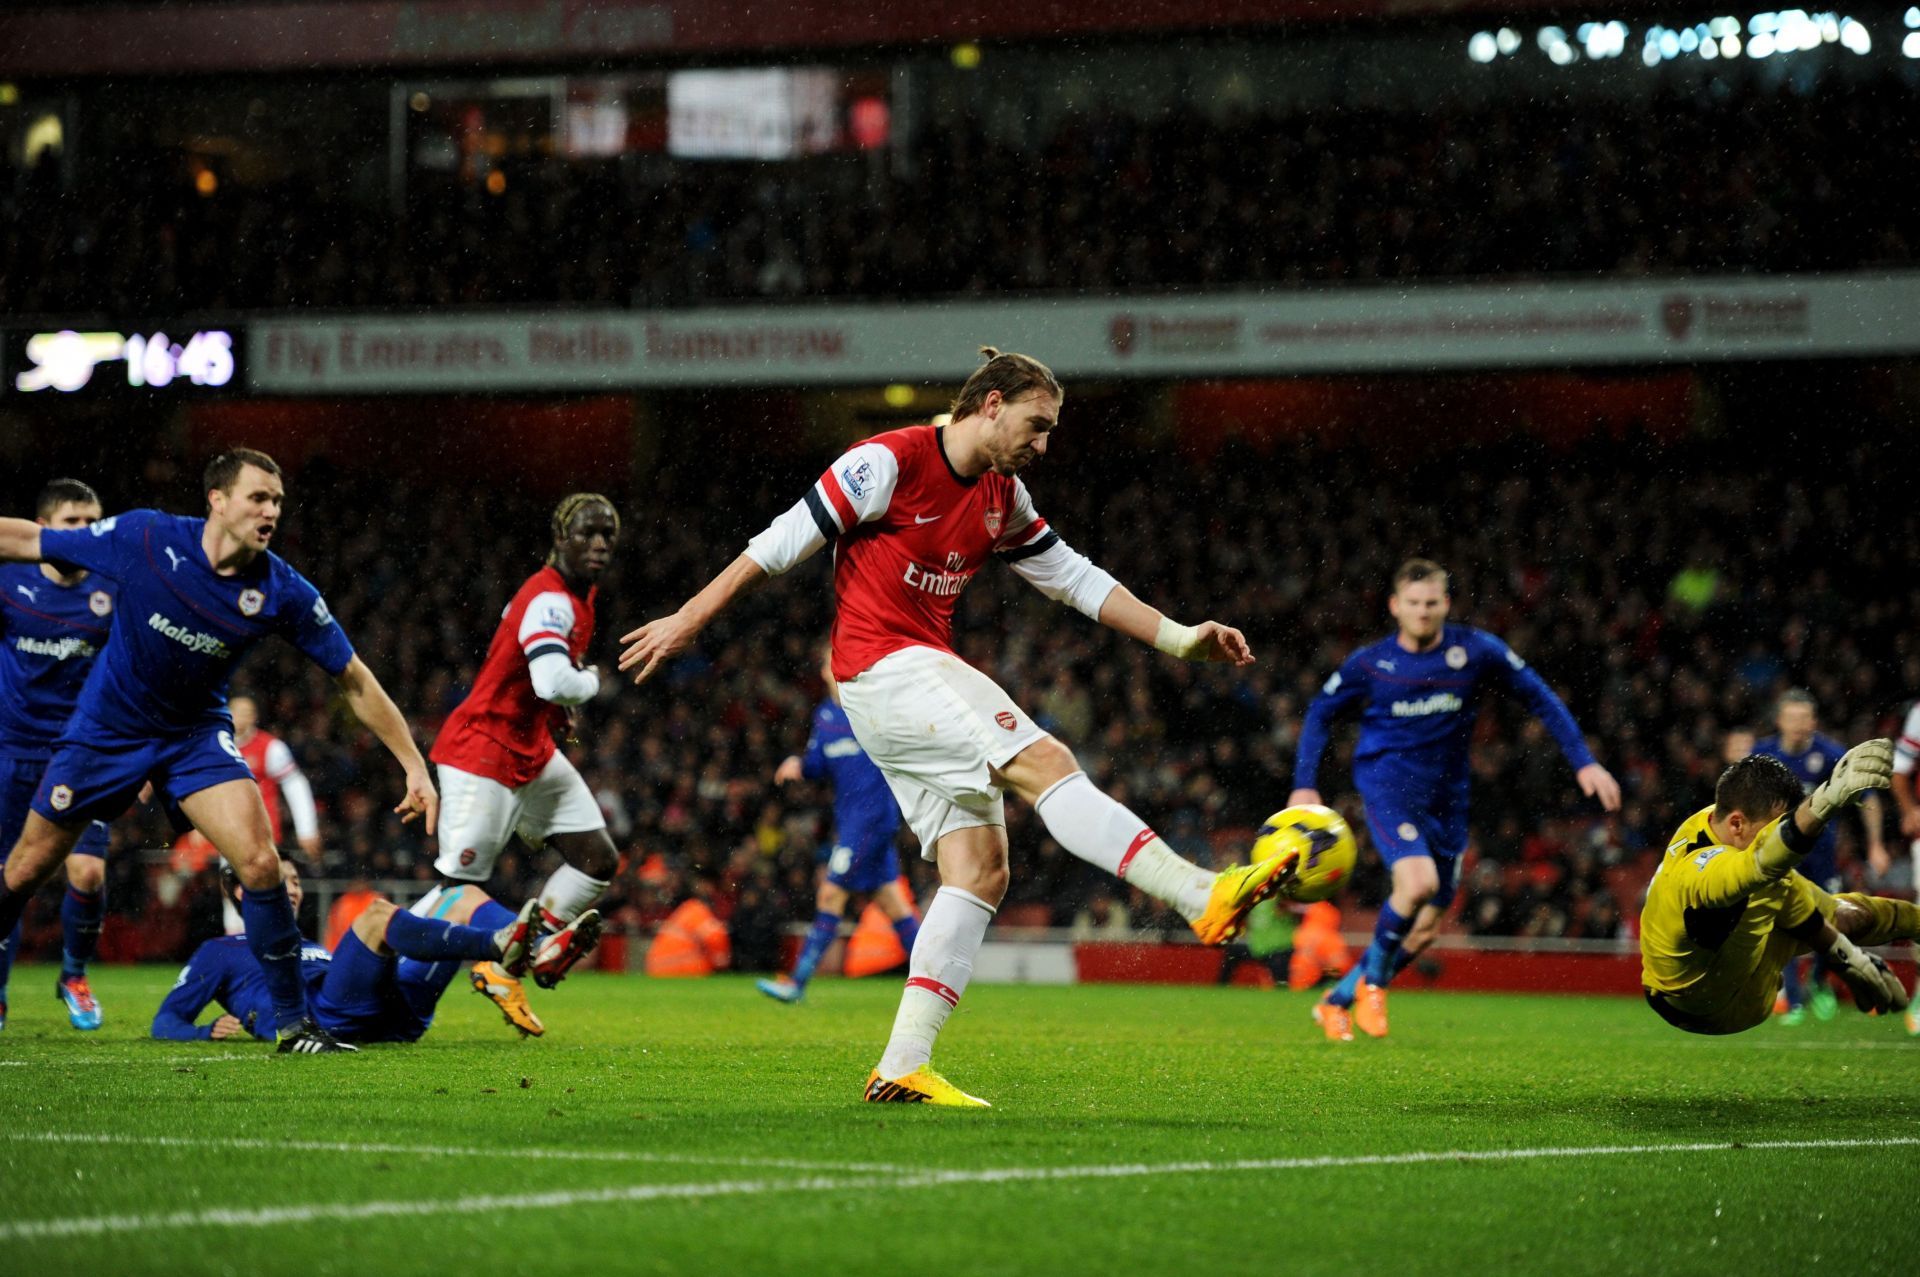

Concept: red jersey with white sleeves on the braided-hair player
[[430, 566, 599, 789]]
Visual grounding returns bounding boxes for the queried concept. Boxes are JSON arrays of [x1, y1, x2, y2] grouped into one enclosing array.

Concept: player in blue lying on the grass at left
[[154, 860, 536, 1050]]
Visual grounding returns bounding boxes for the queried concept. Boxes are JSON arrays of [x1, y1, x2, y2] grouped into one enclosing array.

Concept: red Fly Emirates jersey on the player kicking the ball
[[806, 426, 1058, 680]]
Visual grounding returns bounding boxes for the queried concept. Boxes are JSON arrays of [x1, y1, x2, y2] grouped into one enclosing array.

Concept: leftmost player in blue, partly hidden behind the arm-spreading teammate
[[0, 478, 119, 1029]]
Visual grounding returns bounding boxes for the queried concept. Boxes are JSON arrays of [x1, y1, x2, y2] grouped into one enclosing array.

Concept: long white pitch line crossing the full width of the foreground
[[0, 1137, 1920, 1241]]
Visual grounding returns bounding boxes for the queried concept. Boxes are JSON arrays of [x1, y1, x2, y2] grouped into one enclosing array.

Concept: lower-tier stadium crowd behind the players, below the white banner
[[11, 410, 1920, 967]]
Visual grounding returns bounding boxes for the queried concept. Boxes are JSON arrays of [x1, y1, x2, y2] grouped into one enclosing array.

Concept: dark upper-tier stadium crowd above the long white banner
[[0, 75, 1920, 315]]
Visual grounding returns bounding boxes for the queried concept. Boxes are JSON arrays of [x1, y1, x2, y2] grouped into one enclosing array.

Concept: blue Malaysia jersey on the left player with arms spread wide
[[40, 511, 353, 739]]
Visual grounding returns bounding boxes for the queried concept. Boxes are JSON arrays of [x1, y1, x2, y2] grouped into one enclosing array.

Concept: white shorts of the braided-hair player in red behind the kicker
[[434, 751, 607, 883]]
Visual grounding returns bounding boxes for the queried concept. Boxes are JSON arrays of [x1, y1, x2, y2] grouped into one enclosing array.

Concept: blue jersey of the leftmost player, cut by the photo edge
[[0, 563, 117, 762]]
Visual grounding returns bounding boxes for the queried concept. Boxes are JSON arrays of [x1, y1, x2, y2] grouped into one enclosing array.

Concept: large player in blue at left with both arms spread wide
[[0, 447, 440, 1054]]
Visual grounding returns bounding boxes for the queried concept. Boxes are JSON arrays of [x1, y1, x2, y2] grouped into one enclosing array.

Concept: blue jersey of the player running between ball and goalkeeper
[[1294, 624, 1594, 789]]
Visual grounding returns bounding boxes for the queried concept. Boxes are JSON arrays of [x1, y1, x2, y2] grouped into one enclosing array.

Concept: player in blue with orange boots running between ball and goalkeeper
[[1286, 559, 1620, 1041]]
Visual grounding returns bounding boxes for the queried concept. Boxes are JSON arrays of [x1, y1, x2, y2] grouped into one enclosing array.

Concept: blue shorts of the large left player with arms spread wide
[[33, 724, 253, 828]]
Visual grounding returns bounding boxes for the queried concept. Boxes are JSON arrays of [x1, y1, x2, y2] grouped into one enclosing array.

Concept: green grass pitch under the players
[[0, 968, 1920, 1277]]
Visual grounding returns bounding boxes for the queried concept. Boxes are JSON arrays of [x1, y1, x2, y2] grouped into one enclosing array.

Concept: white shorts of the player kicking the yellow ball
[[841, 647, 1046, 860]]
